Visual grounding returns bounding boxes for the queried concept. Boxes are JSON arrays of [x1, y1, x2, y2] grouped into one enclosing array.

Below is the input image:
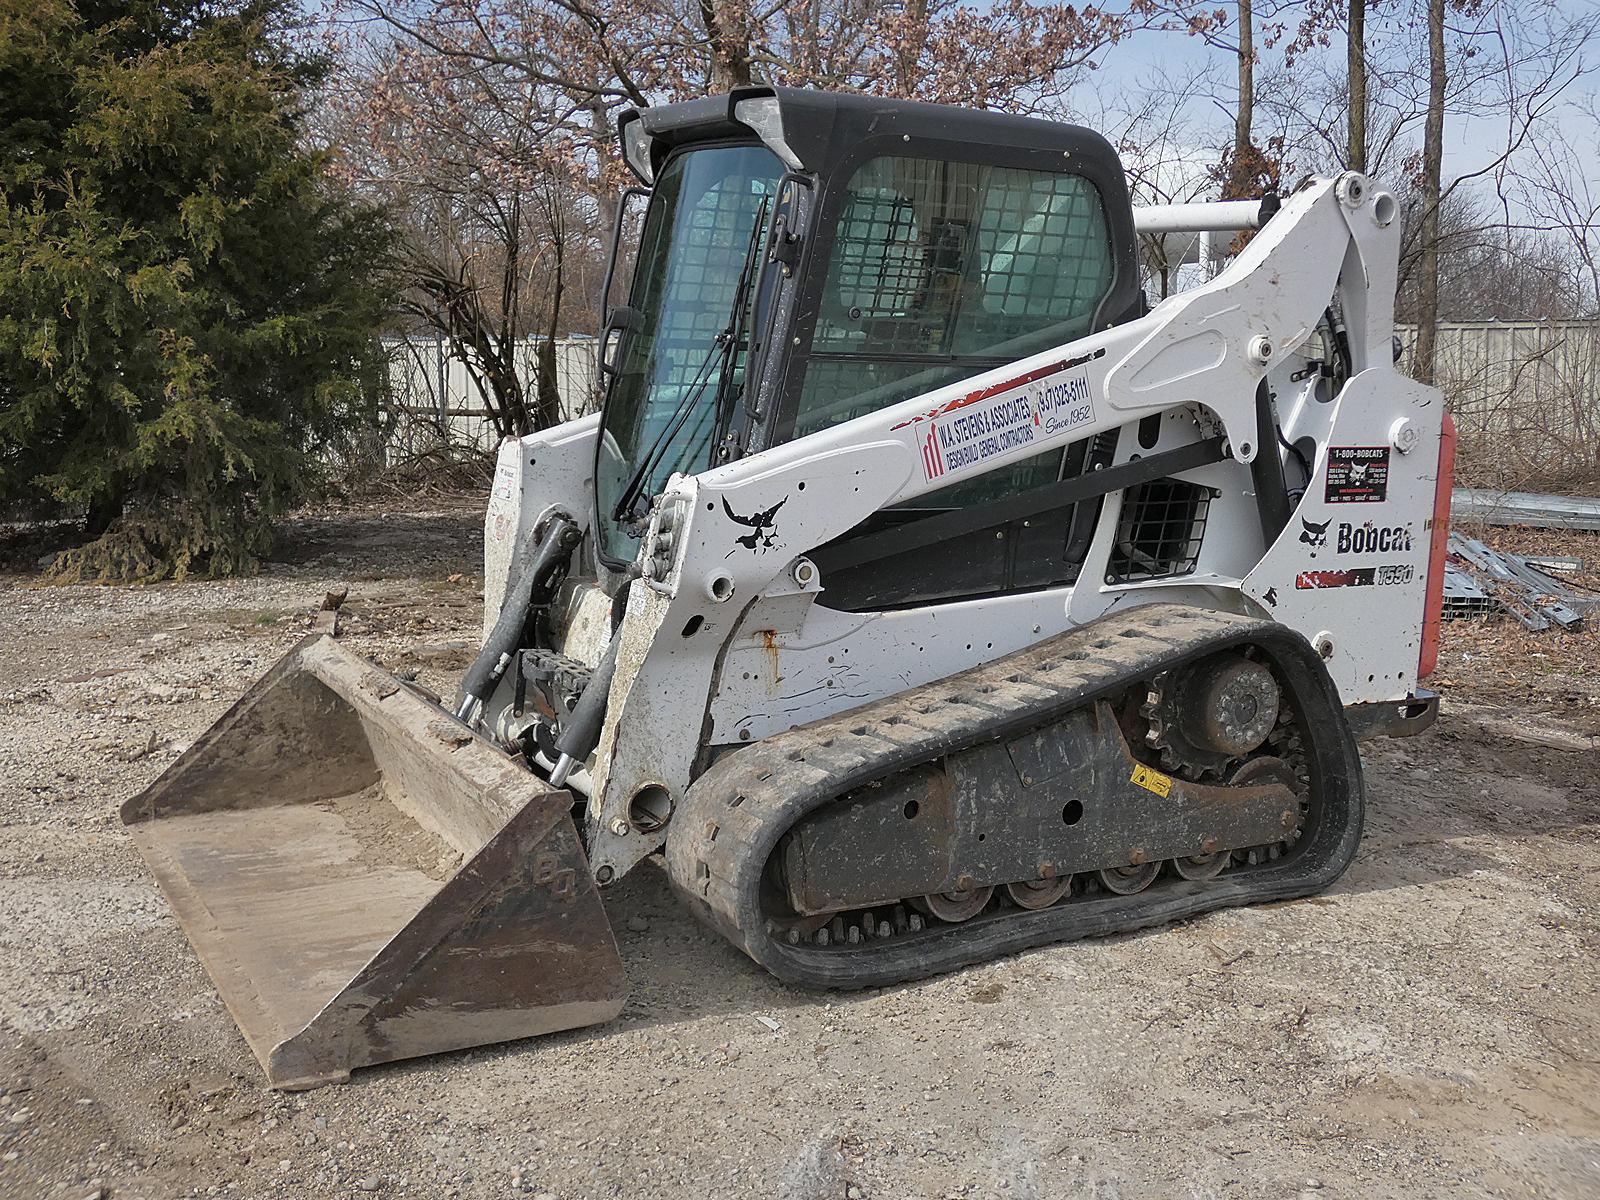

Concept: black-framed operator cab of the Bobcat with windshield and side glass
[[595, 88, 1144, 610]]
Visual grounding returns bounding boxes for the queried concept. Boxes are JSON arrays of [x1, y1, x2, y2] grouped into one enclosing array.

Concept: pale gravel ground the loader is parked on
[[0, 506, 1600, 1200]]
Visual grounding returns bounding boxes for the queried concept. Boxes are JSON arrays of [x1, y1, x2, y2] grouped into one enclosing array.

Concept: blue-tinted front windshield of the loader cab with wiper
[[595, 146, 782, 562]]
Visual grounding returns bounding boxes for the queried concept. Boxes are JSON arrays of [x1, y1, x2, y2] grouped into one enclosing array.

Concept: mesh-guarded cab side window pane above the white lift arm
[[794, 157, 1115, 448]]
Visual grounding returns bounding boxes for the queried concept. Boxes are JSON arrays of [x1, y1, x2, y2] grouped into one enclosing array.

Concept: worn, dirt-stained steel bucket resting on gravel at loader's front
[[122, 637, 626, 1088]]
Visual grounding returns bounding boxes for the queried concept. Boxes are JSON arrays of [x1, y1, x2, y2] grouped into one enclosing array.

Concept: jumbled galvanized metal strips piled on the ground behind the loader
[[1445, 533, 1600, 632]]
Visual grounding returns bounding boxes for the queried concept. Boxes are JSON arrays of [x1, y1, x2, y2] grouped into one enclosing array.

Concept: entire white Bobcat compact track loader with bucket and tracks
[[123, 88, 1453, 1086]]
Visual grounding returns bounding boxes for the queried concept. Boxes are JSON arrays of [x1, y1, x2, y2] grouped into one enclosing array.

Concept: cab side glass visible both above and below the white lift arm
[[794, 157, 1117, 610]]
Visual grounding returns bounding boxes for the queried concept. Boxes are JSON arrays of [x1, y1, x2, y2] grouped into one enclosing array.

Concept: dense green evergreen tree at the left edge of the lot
[[0, 0, 392, 579]]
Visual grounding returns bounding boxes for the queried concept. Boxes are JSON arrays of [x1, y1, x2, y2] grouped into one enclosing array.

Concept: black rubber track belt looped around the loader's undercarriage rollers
[[667, 605, 1365, 989]]
